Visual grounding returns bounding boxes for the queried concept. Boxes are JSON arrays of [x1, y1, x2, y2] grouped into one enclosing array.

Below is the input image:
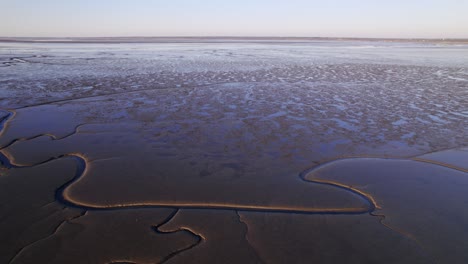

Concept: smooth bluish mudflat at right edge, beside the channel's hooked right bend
[[305, 158, 468, 263]]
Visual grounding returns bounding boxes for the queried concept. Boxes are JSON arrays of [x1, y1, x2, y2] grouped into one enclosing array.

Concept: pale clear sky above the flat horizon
[[0, 0, 468, 38]]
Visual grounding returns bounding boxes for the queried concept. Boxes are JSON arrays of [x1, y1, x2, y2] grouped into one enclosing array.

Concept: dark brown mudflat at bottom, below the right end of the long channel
[[236, 213, 437, 264]]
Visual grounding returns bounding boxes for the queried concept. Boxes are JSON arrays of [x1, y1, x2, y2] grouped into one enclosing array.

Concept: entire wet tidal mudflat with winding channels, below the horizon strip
[[0, 41, 468, 263]]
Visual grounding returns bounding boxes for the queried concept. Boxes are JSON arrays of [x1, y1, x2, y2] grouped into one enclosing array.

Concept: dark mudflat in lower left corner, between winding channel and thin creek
[[0, 159, 84, 263]]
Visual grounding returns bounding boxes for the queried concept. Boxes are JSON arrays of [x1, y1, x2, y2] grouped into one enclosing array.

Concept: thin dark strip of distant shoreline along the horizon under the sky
[[0, 36, 468, 44]]
